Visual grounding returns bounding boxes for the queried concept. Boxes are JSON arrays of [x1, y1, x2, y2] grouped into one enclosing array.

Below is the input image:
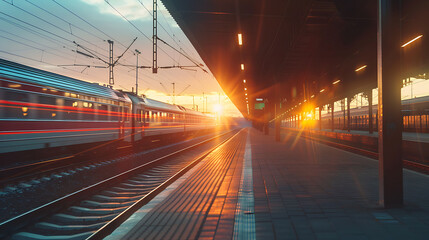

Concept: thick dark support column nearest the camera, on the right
[[377, 0, 403, 207]]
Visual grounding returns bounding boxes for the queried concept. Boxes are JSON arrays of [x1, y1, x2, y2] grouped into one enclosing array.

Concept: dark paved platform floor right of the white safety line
[[250, 130, 429, 239]]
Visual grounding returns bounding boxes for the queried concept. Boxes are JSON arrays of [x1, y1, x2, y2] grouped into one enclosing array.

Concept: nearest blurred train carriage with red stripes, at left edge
[[0, 59, 131, 153]]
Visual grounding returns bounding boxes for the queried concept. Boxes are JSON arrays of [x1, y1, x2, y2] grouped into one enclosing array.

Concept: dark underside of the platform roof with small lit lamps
[[162, 0, 429, 116]]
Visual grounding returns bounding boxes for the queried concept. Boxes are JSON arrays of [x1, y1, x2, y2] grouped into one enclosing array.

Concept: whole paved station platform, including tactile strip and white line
[[106, 129, 429, 239]]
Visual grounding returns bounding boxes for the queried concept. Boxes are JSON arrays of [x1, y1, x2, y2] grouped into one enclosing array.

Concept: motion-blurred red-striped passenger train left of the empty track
[[0, 59, 215, 153]]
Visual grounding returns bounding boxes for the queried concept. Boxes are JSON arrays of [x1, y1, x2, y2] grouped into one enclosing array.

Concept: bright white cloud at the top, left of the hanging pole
[[82, 0, 152, 21]]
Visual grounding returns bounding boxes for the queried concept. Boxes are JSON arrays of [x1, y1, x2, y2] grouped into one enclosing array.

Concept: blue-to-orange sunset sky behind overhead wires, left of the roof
[[0, 0, 241, 116]]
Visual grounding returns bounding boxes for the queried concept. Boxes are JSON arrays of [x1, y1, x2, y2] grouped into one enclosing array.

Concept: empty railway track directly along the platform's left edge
[[0, 128, 236, 239]]
